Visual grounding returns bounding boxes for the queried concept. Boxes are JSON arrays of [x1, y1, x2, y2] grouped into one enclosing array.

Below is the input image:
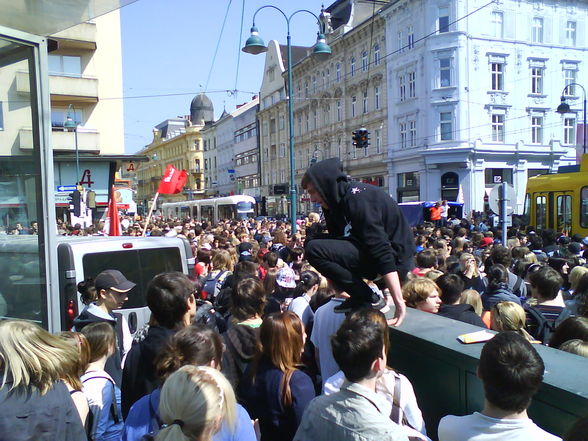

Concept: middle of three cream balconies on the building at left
[[16, 71, 98, 104]]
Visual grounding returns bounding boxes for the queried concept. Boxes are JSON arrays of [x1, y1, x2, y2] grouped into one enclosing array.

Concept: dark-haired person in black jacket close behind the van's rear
[[121, 272, 196, 418]]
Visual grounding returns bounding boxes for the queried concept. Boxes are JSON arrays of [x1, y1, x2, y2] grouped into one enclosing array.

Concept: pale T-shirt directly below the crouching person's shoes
[[310, 298, 345, 383]]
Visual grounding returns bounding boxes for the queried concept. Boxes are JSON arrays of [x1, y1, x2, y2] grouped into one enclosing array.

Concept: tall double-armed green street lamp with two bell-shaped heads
[[241, 5, 331, 233]]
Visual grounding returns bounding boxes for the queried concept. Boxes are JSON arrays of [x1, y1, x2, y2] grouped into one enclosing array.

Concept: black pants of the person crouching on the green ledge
[[304, 239, 377, 303]]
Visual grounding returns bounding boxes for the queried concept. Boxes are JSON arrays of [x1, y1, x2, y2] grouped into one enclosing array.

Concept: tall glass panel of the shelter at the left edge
[[0, 36, 48, 327]]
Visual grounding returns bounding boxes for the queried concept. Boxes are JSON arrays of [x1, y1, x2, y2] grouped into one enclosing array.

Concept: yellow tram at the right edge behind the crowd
[[525, 154, 588, 236]]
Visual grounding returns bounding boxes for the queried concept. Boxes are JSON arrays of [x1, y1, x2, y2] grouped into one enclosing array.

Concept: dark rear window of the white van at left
[[82, 247, 182, 308]]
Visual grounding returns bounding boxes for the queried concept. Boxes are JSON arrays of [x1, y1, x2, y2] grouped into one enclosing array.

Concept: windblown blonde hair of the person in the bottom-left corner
[[0, 320, 78, 395]]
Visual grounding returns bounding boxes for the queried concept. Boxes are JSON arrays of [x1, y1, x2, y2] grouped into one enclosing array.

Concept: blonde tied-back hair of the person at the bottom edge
[[155, 365, 237, 441]]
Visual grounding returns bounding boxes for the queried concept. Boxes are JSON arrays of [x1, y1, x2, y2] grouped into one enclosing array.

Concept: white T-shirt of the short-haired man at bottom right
[[438, 412, 561, 441]]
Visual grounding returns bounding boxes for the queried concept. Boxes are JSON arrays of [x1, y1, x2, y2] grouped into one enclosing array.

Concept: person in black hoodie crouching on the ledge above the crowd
[[301, 158, 415, 326]]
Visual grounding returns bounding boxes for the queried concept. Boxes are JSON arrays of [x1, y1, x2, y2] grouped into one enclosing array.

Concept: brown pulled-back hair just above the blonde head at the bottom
[[155, 323, 224, 381]]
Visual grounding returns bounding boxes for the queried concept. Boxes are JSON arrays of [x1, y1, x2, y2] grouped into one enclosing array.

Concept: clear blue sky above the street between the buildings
[[121, 0, 326, 154]]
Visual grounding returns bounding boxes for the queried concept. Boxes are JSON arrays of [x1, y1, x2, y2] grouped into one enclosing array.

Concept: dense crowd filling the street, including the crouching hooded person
[[0, 161, 588, 441]]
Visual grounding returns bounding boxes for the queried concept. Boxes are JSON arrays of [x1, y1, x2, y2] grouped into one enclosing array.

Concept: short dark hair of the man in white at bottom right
[[478, 331, 545, 412]]
